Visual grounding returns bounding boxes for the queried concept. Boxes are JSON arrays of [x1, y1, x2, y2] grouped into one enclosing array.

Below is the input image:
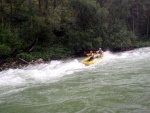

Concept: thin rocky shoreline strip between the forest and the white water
[[0, 42, 150, 71]]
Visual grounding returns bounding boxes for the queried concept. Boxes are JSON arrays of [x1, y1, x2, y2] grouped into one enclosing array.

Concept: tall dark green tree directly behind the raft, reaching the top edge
[[65, 0, 102, 54]]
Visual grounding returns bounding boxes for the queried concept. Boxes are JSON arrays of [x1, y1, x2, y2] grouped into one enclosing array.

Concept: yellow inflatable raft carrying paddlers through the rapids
[[82, 54, 102, 66]]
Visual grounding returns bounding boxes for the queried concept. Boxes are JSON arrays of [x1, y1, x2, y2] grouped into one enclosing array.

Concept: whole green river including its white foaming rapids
[[0, 47, 150, 113]]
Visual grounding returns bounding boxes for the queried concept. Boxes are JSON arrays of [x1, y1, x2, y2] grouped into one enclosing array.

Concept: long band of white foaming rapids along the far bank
[[0, 47, 150, 87]]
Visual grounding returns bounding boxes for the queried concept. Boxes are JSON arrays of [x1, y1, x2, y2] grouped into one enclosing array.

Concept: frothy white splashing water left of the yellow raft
[[0, 59, 85, 86]]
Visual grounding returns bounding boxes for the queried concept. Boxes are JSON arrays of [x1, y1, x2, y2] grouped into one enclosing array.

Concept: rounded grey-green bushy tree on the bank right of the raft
[[107, 21, 137, 49]]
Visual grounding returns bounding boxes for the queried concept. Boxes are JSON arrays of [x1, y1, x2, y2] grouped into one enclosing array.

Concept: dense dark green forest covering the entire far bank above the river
[[0, 0, 150, 62]]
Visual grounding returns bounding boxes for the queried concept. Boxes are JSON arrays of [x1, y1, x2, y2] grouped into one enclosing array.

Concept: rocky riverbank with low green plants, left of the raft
[[0, 47, 71, 71]]
